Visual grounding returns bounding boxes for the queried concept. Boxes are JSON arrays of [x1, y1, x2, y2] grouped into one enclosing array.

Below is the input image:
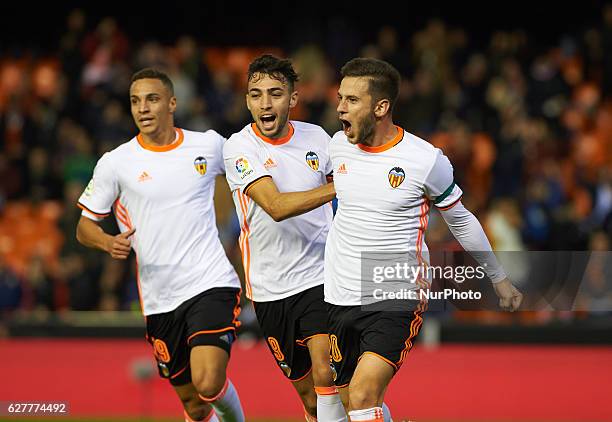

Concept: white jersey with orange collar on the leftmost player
[[79, 129, 240, 315]]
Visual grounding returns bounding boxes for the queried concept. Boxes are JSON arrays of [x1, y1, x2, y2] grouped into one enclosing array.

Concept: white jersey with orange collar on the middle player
[[223, 121, 333, 302]]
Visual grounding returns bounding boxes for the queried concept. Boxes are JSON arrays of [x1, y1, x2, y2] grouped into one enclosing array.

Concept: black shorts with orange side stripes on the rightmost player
[[327, 303, 423, 387]]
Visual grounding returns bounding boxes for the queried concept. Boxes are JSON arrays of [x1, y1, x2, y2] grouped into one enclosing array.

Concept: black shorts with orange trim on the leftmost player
[[146, 287, 240, 385]]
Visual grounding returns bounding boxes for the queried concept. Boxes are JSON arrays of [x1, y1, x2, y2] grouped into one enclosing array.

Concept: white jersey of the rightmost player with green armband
[[325, 127, 462, 306]]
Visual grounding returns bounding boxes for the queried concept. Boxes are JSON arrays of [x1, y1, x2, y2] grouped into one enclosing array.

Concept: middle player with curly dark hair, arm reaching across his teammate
[[223, 55, 346, 421]]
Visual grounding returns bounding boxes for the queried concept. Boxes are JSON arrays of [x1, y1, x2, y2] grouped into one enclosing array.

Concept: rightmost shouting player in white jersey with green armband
[[325, 58, 522, 422]]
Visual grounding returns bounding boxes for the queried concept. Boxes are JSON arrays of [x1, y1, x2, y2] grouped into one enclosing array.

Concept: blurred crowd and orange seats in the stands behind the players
[[0, 6, 612, 320]]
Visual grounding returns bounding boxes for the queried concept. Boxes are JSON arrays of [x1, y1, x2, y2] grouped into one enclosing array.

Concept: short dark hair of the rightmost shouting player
[[340, 57, 401, 110]]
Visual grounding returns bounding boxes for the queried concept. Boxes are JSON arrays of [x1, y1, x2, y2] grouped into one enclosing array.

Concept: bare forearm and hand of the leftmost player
[[76, 215, 136, 259]]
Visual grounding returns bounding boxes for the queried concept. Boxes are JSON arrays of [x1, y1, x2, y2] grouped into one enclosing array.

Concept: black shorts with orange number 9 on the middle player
[[253, 285, 327, 381]]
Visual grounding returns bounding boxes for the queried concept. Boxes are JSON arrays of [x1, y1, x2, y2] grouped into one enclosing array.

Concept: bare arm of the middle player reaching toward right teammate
[[244, 176, 336, 221]]
